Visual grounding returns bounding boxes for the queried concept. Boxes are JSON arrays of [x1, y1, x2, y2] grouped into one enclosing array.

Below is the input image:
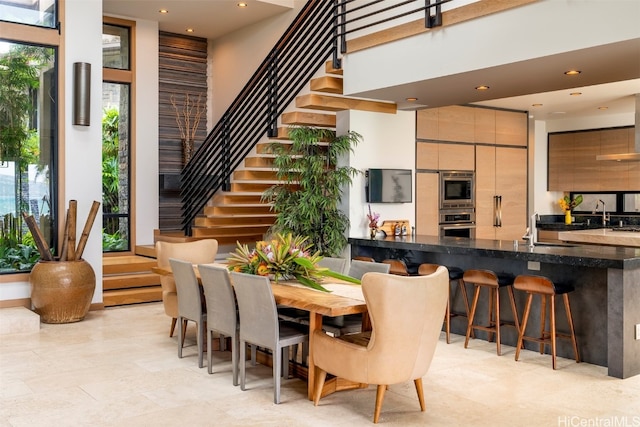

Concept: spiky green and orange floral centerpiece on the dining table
[[227, 233, 360, 292]]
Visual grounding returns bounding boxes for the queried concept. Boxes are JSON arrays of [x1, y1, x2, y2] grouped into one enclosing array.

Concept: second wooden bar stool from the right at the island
[[463, 270, 520, 356]]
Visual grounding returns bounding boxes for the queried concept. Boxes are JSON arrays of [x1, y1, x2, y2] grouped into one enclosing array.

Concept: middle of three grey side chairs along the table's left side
[[198, 264, 239, 385]]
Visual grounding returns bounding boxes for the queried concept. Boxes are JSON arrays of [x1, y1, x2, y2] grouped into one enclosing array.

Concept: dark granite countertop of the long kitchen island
[[349, 235, 640, 269]]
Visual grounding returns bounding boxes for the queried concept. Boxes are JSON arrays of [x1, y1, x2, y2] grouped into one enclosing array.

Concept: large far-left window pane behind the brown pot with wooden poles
[[0, 40, 58, 273]]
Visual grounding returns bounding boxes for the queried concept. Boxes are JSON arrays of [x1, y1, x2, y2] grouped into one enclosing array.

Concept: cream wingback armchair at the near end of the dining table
[[311, 267, 449, 423]]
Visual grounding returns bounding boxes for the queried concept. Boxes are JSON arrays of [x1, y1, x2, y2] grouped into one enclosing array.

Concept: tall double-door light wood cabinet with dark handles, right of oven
[[476, 145, 527, 240]]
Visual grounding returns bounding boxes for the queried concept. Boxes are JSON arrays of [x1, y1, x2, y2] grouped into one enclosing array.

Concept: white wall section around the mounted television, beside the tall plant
[[338, 110, 416, 237]]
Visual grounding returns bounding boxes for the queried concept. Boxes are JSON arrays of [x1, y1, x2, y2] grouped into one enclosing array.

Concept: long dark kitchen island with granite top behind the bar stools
[[349, 236, 640, 378]]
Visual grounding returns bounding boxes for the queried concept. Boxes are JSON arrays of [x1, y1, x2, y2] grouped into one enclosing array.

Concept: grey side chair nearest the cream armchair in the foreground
[[230, 272, 309, 404]]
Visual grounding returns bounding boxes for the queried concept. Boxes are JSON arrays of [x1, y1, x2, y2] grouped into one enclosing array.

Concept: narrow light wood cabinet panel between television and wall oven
[[416, 172, 439, 236]]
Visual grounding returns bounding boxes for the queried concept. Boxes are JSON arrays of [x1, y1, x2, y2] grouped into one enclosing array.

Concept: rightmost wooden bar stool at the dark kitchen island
[[513, 275, 580, 369]]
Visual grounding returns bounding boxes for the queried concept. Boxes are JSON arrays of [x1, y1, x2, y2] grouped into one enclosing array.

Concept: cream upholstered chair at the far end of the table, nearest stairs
[[156, 239, 218, 337]]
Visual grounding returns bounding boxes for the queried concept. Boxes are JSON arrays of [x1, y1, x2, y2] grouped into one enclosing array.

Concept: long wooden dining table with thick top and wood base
[[152, 265, 370, 400]]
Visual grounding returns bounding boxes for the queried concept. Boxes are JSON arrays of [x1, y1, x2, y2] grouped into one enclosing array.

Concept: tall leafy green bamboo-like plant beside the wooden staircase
[[262, 126, 362, 256]]
